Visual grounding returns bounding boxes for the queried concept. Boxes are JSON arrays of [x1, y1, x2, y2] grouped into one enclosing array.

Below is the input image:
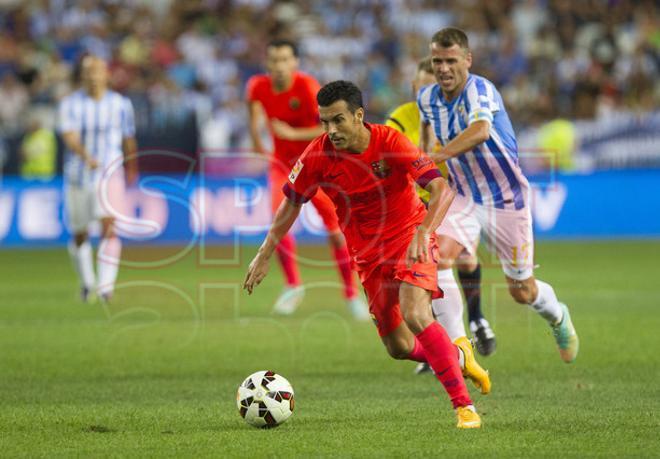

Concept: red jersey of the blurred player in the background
[[246, 72, 321, 167]]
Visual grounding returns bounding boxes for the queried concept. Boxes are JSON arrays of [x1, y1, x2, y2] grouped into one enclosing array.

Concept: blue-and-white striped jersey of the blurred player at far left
[[59, 89, 135, 186]]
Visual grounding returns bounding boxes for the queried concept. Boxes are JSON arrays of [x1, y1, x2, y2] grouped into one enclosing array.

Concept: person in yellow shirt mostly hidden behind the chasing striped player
[[385, 57, 496, 374]]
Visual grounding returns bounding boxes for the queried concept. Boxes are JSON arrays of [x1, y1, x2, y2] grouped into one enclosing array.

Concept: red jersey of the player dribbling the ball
[[283, 123, 441, 271]]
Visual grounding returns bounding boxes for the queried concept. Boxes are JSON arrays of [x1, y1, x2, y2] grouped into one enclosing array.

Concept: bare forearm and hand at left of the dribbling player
[[243, 198, 302, 294]]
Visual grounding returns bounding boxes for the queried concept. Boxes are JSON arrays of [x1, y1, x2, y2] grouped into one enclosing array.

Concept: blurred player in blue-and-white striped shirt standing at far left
[[59, 55, 137, 302]]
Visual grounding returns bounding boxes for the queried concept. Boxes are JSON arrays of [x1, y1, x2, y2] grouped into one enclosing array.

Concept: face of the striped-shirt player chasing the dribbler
[[431, 43, 472, 99]]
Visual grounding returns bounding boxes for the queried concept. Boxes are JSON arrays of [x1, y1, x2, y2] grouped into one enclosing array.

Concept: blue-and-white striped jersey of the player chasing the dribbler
[[417, 74, 529, 209]]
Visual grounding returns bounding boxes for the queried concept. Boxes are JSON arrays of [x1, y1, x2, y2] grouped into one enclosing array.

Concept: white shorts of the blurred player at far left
[[64, 174, 125, 234]]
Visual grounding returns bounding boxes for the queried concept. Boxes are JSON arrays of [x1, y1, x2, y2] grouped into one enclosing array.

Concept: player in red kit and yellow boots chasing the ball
[[243, 81, 490, 428]]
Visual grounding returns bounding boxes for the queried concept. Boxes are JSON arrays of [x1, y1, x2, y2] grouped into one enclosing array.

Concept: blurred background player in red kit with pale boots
[[246, 40, 369, 320]]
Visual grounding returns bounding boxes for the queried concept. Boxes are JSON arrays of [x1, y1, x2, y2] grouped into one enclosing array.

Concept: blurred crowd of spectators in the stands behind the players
[[0, 0, 660, 176]]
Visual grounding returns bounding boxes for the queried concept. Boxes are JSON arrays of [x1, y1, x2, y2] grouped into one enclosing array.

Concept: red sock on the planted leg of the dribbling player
[[410, 322, 472, 408]]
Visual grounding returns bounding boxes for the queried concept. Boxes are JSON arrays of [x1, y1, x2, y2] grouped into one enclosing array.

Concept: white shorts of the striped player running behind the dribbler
[[436, 195, 534, 280]]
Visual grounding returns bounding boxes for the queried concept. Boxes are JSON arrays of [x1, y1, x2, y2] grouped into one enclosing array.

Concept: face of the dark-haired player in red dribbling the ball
[[319, 100, 364, 150]]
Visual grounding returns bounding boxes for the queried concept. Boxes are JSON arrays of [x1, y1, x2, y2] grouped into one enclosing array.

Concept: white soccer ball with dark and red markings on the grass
[[236, 371, 294, 428]]
